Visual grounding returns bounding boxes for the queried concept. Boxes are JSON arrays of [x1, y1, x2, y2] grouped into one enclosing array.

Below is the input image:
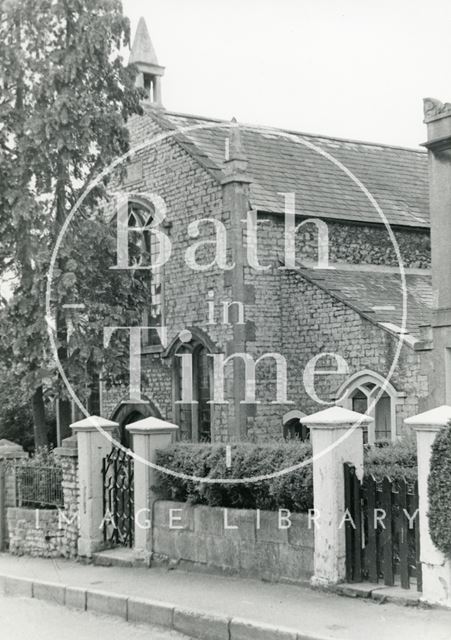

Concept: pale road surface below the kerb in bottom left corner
[[0, 596, 189, 640]]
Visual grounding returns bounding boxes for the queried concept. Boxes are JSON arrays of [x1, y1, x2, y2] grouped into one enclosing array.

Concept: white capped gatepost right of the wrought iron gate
[[126, 417, 178, 562]]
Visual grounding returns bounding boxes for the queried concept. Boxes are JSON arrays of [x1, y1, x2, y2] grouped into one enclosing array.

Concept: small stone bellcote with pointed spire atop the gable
[[128, 18, 164, 107]]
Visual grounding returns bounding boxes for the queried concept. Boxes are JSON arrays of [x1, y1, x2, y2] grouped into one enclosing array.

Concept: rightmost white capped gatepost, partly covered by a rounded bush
[[404, 405, 451, 607]]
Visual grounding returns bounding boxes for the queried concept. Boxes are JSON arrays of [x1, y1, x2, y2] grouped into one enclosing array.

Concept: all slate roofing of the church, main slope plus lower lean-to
[[146, 111, 432, 346]]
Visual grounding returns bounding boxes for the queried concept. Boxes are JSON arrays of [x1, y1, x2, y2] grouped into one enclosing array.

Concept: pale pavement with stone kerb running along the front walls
[[0, 554, 451, 640]]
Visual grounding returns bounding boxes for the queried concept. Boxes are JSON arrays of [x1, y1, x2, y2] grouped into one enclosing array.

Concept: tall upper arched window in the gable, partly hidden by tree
[[128, 200, 163, 348]]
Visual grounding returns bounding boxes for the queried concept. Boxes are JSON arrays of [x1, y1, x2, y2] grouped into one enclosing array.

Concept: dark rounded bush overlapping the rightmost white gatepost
[[428, 427, 451, 555]]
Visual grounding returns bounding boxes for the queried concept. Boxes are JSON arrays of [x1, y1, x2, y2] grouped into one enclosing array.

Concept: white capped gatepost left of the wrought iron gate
[[71, 416, 119, 558]]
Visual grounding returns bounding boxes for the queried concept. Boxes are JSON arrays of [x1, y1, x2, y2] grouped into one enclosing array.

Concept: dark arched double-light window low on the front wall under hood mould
[[173, 338, 212, 442]]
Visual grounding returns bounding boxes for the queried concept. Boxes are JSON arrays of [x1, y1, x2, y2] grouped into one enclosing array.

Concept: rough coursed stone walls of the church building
[[103, 106, 430, 441]]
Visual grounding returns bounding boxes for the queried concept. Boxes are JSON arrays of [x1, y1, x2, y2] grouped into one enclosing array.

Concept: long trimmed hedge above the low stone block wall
[[155, 442, 313, 513]]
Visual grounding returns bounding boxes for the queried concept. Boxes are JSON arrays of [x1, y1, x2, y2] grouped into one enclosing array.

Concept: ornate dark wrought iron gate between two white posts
[[102, 446, 135, 547]]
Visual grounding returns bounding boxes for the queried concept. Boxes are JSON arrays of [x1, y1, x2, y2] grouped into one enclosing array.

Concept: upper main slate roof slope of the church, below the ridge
[[157, 111, 429, 228]]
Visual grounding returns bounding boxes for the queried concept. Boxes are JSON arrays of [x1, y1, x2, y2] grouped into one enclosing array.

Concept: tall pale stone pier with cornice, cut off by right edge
[[424, 98, 451, 408]]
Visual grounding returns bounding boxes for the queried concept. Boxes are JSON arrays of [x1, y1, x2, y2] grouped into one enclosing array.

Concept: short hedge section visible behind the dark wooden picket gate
[[365, 434, 418, 483]]
